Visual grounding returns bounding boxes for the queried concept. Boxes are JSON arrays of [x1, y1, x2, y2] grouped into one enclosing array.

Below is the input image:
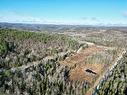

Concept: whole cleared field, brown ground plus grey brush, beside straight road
[[60, 46, 122, 85]]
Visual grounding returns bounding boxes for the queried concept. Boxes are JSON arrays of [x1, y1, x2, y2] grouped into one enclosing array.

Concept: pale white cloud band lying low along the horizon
[[0, 11, 127, 25]]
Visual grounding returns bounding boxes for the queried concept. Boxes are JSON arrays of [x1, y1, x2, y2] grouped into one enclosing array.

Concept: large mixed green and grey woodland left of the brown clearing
[[0, 29, 89, 95]]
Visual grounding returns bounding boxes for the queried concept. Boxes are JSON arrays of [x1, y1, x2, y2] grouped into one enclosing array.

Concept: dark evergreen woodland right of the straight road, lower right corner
[[94, 53, 127, 95]]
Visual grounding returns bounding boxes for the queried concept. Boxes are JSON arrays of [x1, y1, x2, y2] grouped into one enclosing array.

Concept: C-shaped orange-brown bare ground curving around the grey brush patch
[[61, 46, 104, 83]]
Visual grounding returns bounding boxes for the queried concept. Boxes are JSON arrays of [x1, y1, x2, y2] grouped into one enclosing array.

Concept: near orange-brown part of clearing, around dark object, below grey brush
[[70, 64, 104, 84]]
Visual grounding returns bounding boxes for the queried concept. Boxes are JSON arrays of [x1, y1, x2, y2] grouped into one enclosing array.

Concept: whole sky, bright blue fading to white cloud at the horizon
[[0, 0, 127, 25]]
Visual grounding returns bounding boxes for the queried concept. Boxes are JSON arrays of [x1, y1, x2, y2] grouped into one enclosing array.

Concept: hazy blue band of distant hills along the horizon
[[0, 22, 127, 32]]
